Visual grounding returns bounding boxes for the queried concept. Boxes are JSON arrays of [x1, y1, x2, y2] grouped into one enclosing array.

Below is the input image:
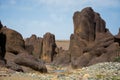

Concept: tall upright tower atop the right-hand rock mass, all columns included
[[73, 7, 107, 42]]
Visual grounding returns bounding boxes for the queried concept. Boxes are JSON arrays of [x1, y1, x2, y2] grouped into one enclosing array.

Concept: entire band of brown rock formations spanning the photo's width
[[0, 7, 120, 72]]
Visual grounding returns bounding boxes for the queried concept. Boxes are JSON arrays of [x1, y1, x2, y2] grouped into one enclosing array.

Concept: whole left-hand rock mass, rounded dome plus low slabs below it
[[0, 23, 47, 72]]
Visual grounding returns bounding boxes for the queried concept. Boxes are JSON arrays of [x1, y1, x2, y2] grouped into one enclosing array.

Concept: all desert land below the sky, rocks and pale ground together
[[0, 7, 120, 80]]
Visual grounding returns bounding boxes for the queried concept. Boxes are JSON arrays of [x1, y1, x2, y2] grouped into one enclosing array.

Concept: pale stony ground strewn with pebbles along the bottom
[[0, 62, 120, 80]]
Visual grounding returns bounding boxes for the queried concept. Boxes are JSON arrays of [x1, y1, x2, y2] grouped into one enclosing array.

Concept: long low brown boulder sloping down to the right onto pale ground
[[14, 53, 47, 73]]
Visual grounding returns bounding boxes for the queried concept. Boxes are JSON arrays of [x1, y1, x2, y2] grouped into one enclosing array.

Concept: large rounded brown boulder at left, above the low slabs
[[1, 27, 25, 54]]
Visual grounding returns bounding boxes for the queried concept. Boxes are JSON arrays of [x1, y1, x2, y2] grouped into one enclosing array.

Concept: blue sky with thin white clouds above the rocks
[[0, 0, 120, 39]]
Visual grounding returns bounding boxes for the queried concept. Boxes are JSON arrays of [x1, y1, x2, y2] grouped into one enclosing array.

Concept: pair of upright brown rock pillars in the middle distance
[[25, 33, 56, 63]]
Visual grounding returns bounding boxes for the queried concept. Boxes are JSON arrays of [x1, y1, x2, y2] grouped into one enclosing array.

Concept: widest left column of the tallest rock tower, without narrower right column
[[73, 8, 95, 41]]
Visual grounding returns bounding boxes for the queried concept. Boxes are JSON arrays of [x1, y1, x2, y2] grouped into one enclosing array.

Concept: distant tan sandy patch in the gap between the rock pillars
[[56, 40, 70, 50]]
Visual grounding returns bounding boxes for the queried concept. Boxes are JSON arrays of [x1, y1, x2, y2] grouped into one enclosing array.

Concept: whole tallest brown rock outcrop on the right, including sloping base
[[69, 7, 120, 68]]
